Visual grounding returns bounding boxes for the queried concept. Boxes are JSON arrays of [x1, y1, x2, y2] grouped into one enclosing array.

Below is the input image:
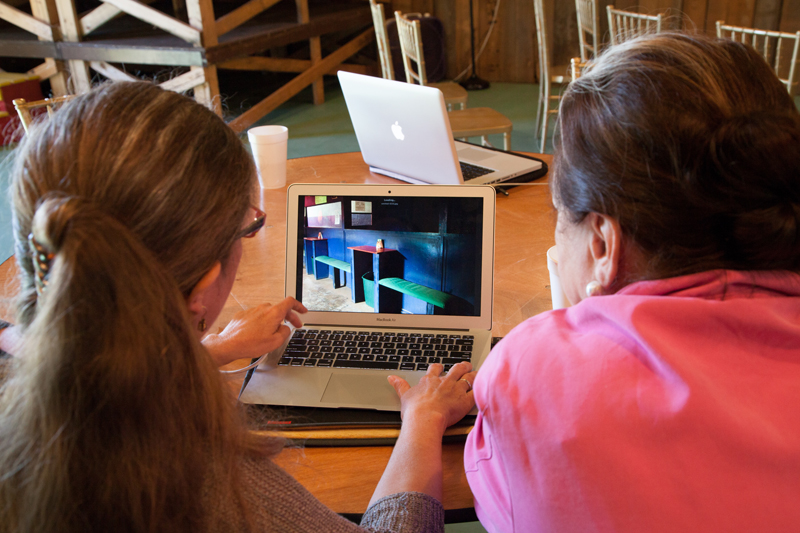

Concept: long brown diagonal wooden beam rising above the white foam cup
[[228, 28, 375, 133]]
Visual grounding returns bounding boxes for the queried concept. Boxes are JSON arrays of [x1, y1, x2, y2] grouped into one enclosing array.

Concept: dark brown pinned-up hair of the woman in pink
[[551, 33, 800, 278]]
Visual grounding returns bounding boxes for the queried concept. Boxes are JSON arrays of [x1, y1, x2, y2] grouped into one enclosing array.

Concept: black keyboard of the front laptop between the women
[[278, 328, 475, 371]]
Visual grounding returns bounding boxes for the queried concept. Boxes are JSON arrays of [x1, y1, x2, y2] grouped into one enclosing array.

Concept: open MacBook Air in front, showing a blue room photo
[[240, 184, 495, 411]]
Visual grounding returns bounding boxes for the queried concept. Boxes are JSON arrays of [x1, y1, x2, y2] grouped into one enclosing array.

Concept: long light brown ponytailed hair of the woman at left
[[0, 83, 276, 531]]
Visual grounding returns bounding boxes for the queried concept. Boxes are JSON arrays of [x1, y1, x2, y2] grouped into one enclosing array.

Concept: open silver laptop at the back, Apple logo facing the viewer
[[338, 71, 542, 185]]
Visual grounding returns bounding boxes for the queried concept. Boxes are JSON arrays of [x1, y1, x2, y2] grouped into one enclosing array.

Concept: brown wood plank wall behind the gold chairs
[[386, 0, 800, 83]]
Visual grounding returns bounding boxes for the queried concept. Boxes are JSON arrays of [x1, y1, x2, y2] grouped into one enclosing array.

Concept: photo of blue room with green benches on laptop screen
[[295, 193, 484, 317]]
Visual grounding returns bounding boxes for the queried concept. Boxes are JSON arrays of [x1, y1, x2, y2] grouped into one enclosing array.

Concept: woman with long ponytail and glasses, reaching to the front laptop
[[0, 83, 474, 532]]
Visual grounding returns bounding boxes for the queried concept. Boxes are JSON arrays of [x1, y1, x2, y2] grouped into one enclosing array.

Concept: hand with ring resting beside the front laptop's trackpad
[[389, 362, 477, 433]]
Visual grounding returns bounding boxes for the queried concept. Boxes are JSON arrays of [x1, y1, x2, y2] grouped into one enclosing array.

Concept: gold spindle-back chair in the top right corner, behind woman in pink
[[717, 20, 800, 95]]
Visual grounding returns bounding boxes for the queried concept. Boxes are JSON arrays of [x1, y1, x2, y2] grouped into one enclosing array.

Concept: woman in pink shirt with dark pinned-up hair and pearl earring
[[465, 34, 800, 532]]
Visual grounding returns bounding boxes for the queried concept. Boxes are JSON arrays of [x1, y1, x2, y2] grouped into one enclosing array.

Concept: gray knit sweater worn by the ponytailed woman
[[205, 459, 444, 533]]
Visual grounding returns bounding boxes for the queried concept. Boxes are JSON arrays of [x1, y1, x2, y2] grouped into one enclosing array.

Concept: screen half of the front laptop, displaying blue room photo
[[286, 184, 495, 330]]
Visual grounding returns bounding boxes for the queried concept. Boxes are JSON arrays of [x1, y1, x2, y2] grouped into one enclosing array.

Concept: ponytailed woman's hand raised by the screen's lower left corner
[[203, 297, 307, 366]]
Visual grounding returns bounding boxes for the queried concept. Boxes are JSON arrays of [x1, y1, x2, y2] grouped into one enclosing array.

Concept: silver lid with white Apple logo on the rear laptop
[[338, 71, 462, 184]]
